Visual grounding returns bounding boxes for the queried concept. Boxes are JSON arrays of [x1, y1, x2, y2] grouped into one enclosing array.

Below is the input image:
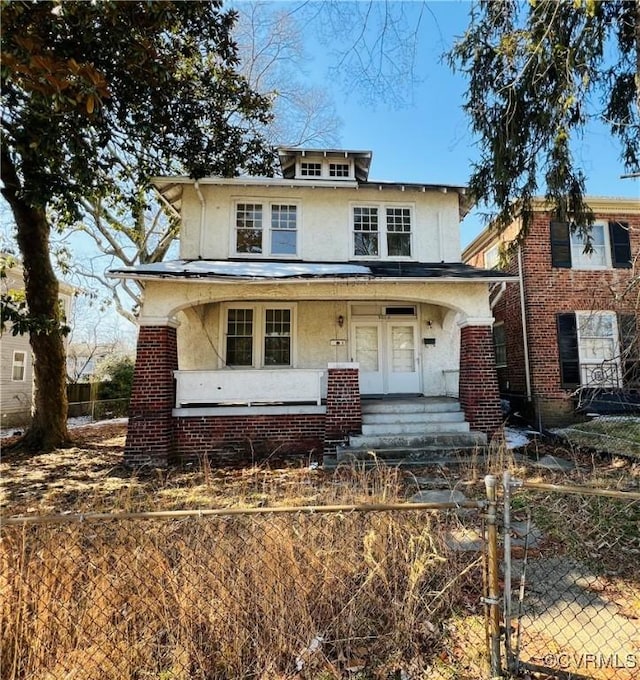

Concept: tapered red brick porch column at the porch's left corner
[[124, 322, 178, 467]]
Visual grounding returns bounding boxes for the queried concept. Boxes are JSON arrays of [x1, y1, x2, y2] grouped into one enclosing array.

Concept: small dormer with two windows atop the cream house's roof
[[278, 147, 371, 183]]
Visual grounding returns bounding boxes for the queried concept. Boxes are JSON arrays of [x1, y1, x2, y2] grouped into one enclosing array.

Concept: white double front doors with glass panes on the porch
[[353, 319, 420, 394]]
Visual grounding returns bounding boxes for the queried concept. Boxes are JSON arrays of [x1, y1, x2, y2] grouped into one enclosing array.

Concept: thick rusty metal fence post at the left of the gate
[[484, 475, 502, 678]]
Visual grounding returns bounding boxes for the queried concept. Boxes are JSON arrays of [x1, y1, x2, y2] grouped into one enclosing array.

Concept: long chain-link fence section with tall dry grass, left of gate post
[[0, 501, 487, 680]]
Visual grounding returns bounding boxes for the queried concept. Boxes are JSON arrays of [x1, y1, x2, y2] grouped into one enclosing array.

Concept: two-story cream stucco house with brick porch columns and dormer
[[111, 149, 510, 465]]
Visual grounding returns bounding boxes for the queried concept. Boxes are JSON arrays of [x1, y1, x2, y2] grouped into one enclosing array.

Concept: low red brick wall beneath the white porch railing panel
[[173, 414, 325, 467]]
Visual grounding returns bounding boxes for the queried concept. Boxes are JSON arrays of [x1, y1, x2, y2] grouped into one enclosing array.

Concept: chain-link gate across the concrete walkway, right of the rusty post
[[504, 475, 640, 680]]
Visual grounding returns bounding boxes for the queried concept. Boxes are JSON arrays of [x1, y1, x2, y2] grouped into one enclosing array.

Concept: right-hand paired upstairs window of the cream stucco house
[[353, 206, 412, 257]]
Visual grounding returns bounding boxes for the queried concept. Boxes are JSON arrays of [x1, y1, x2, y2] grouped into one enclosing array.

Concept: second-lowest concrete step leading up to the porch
[[349, 430, 487, 451]]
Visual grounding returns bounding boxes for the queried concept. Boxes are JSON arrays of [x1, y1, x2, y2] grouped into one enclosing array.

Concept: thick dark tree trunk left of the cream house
[[2, 154, 69, 452]]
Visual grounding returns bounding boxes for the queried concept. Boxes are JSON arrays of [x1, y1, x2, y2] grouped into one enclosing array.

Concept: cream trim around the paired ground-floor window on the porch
[[218, 301, 298, 370]]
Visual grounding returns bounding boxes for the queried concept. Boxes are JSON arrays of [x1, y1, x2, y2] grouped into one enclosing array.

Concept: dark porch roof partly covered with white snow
[[109, 260, 517, 282]]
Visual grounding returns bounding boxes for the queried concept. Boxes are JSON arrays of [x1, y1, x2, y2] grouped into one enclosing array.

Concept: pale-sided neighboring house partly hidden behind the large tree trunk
[[0, 253, 74, 427]]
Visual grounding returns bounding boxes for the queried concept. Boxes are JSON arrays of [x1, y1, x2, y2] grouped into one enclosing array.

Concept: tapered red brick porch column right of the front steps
[[460, 324, 502, 439]]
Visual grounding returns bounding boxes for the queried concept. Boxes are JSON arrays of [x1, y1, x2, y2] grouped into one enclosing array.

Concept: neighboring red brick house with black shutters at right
[[463, 197, 640, 427]]
